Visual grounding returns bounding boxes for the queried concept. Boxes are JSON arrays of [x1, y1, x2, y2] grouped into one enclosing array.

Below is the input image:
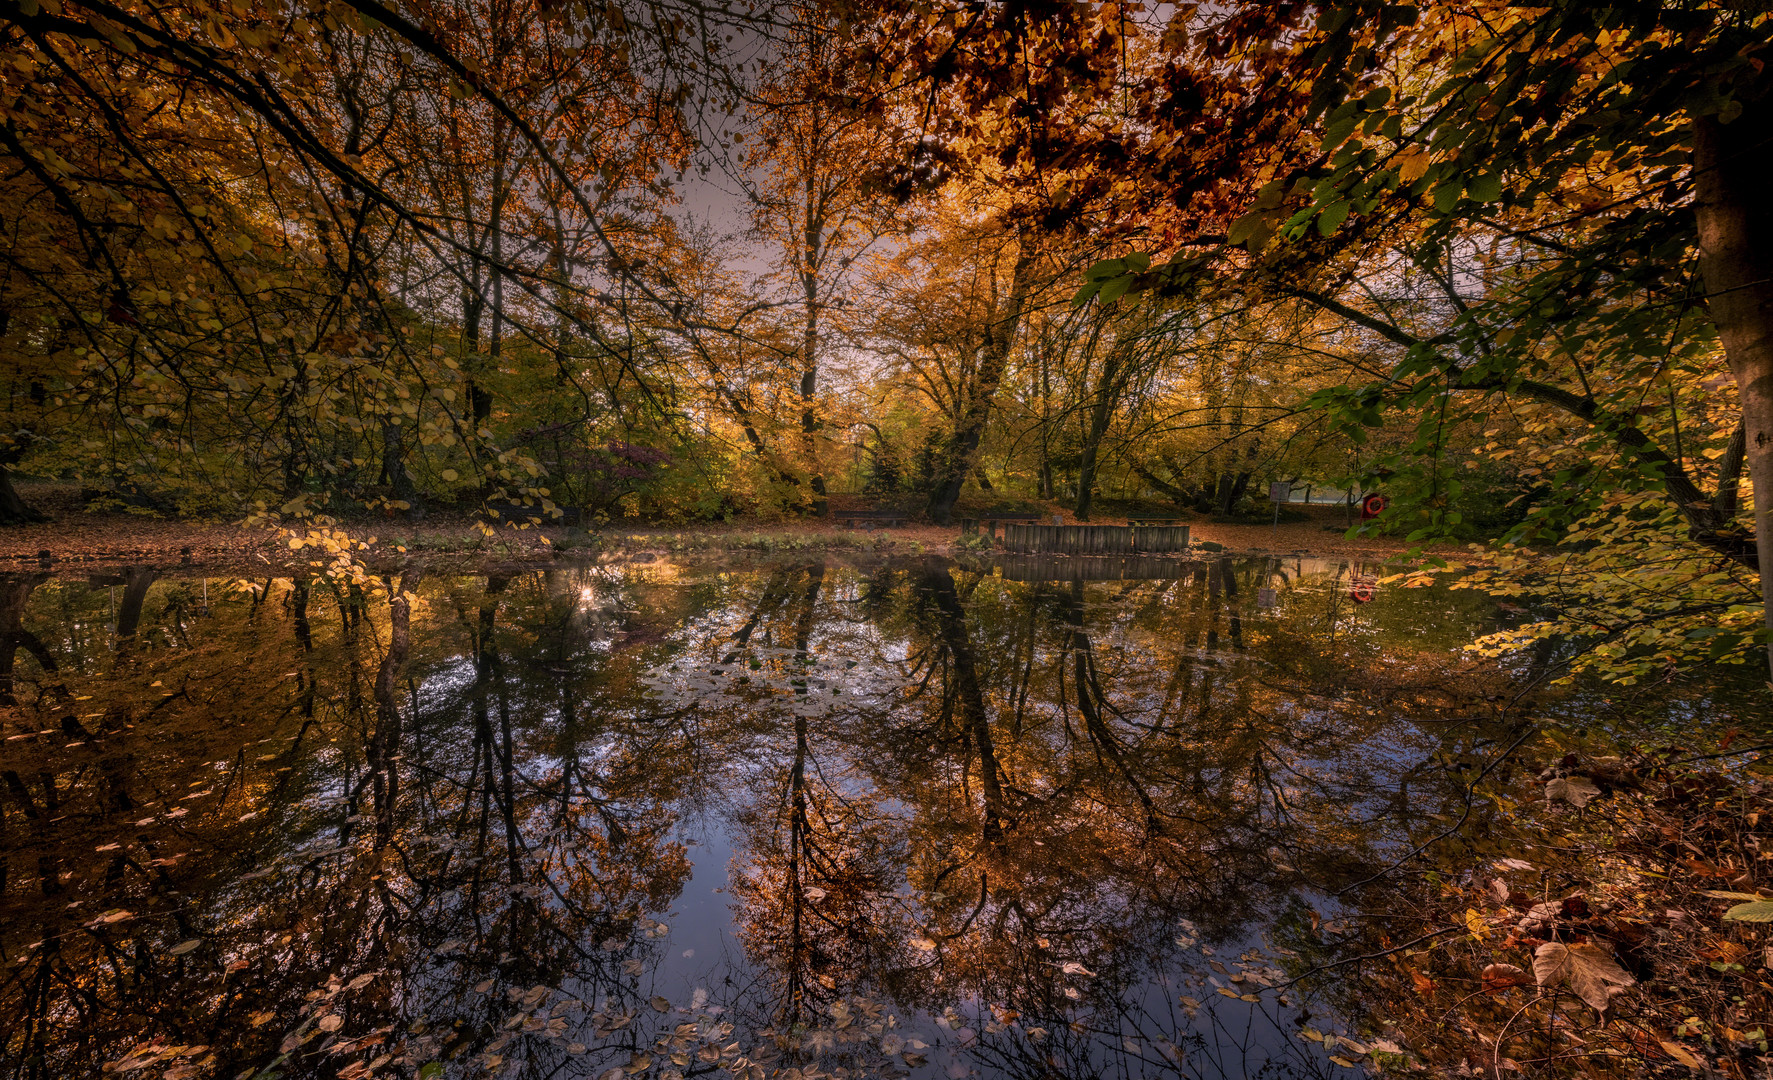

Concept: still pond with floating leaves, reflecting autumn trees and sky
[[0, 557, 1745, 1080]]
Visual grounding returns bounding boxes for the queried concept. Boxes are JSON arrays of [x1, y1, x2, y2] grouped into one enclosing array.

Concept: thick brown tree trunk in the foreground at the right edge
[[1693, 99, 1773, 672]]
